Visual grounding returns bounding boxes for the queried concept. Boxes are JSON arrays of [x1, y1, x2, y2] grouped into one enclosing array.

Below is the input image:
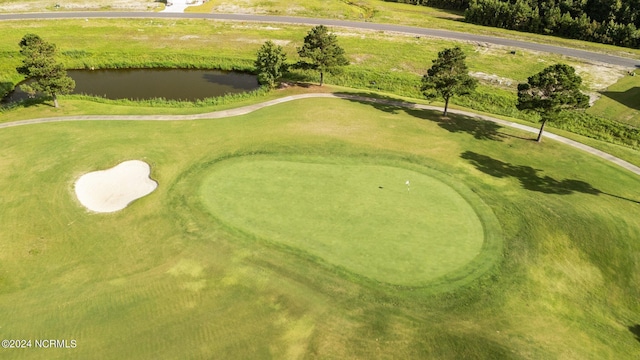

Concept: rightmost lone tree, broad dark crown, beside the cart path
[[516, 64, 589, 142]]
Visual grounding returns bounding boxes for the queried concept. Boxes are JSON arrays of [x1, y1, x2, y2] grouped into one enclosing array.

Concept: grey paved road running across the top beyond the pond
[[0, 12, 640, 68]]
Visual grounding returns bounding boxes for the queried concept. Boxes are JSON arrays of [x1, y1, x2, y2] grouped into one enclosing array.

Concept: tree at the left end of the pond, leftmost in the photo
[[16, 34, 76, 107]]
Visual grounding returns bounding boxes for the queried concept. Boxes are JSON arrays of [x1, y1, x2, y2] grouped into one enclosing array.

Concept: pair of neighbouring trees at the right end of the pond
[[255, 25, 349, 88]]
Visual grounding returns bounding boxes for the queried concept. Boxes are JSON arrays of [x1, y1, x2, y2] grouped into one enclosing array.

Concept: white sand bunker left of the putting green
[[75, 160, 158, 213]]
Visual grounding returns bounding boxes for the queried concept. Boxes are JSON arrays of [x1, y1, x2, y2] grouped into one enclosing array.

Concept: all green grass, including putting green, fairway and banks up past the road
[[0, 4, 640, 360]]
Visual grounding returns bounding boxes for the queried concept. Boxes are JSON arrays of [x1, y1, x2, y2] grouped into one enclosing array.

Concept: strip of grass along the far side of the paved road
[[5, 0, 640, 58]]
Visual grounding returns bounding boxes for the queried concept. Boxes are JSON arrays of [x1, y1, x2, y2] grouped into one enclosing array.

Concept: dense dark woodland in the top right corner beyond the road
[[464, 0, 640, 48]]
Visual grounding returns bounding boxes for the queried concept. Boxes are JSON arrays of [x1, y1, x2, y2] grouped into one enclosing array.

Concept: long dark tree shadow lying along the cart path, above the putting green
[[336, 93, 505, 141]]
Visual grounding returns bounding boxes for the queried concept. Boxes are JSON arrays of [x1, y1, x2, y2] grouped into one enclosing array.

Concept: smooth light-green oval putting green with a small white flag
[[201, 157, 484, 286]]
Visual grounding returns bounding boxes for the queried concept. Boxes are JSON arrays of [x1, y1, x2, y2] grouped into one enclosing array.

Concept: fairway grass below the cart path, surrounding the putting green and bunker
[[0, 99, 640, 359]]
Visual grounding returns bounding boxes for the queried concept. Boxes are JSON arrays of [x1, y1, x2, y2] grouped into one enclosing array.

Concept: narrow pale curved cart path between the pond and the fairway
[[0, 93, 640, 175]]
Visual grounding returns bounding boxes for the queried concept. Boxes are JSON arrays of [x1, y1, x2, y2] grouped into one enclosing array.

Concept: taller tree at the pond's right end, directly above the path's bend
[[297, 25, 349, 86]]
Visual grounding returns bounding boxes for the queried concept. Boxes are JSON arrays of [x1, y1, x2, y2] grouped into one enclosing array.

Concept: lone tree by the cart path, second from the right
[[420, 46, 478, 116]]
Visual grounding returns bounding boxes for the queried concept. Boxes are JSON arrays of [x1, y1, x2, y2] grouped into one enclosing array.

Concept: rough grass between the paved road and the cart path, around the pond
[[0, 20, 637, 155]]
